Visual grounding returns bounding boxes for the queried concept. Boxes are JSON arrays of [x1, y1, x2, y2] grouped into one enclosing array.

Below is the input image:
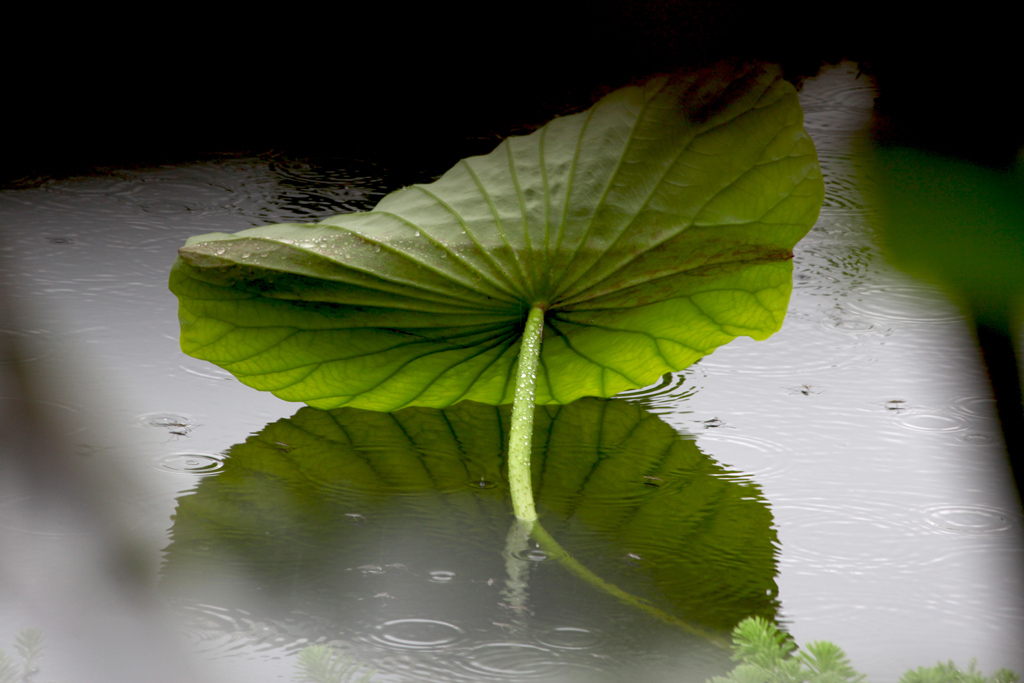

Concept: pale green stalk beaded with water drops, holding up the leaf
[[509, 305, 544, 522]]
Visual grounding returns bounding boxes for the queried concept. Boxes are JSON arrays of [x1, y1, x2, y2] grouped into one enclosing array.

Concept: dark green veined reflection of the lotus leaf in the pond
[[164, 399, 776, 630]]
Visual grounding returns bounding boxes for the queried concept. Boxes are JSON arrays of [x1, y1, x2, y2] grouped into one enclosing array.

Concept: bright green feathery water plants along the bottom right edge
[[710, 616, 1020, 683]]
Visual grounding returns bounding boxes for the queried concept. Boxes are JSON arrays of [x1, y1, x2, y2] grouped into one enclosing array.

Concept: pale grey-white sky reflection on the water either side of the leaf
[[0, 61, 1024, 681]]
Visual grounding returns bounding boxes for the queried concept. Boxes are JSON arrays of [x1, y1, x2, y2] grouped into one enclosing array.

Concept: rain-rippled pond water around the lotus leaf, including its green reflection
[[0, 65, 1024, 682]]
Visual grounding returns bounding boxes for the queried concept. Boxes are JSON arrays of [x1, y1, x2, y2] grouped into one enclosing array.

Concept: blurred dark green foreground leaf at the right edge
[[864, 144, 1024, 496]]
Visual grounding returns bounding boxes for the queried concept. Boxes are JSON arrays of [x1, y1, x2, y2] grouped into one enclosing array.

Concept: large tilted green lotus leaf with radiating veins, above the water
[[171, 61, 823, 411]]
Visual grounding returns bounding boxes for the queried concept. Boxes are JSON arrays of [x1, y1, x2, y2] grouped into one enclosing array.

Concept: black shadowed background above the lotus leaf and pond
[[6, 0, 1024, 186]]
